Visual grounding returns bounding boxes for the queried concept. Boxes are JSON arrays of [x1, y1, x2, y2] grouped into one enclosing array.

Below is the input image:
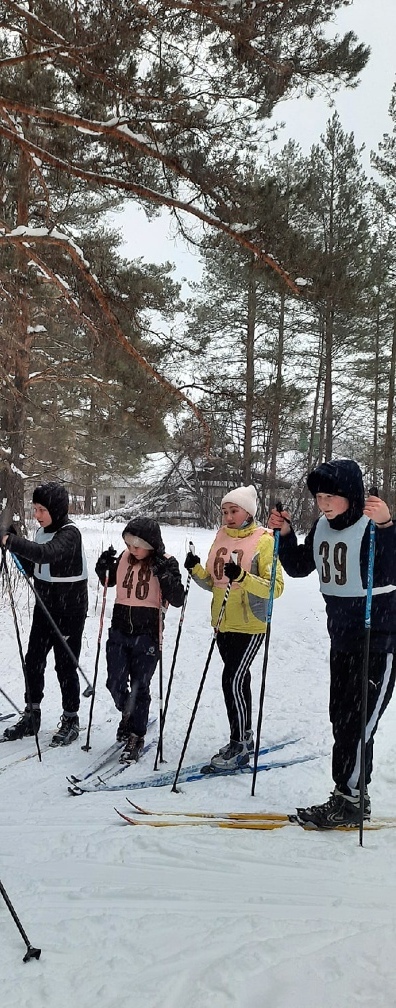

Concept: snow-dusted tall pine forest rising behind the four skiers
[[0, 0, 396, 528]]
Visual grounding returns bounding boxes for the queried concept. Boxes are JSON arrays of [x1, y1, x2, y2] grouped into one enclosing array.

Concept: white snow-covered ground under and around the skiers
[[0, 519, 396, 1008]]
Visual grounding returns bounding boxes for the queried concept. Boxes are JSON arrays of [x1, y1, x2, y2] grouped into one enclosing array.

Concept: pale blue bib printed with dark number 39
[[313, 515, 369, 598]]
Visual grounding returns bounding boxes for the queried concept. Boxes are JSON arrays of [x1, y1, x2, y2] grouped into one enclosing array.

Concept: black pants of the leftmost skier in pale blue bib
[[25, 604, 86, 714]]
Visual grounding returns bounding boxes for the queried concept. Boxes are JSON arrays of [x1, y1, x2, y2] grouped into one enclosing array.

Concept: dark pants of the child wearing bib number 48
[[106, 627, 159, 738]]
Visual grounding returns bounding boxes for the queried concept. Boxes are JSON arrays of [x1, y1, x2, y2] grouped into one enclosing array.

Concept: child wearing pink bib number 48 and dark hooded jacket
[[95, 517, 184, 763]]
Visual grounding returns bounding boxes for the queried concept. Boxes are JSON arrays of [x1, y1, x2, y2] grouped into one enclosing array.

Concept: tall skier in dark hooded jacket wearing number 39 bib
[[269, 459, 396, 829]]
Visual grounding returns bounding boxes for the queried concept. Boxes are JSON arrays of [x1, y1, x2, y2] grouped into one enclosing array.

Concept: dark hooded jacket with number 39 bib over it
[[279, 459, 396, 652]]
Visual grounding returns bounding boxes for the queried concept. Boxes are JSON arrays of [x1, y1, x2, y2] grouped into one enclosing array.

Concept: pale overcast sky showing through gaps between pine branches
[[115, 0, 396, 280]]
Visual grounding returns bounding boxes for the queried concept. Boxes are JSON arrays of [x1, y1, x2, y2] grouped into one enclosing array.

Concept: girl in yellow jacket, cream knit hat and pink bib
[[184, 486, 283, 771]]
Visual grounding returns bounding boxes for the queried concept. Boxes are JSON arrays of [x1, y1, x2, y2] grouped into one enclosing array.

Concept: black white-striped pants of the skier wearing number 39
[[329, 648, 396, 794]]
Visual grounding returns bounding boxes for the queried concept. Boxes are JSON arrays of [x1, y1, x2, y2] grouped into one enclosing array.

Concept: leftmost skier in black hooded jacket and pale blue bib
[[1, 482, 88, 746]]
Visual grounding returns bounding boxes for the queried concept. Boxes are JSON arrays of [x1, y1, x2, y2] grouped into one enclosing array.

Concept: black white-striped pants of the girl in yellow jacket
[[217, 631, 264, 742]]
